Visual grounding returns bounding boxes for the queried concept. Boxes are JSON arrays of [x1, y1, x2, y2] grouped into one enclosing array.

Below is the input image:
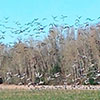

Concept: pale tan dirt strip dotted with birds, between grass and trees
[[0, 84, 100, 90]]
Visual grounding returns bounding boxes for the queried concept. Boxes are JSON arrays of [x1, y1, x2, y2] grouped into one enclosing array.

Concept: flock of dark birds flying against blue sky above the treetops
[[0, 15, 100, 45]]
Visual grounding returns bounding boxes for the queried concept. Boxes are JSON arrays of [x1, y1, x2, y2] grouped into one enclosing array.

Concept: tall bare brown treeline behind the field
[[0, 23, 100, 85]]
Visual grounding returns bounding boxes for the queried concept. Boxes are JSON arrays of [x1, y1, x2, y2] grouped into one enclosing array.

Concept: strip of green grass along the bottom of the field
[[0, 90, 100, 100]]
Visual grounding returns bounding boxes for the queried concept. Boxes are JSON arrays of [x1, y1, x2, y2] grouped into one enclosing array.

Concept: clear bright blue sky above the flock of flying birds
[[0, 0, 100, 41]]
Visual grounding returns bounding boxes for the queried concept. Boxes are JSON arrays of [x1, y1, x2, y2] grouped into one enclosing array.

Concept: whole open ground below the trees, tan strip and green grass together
[[0, 85, 100, 100]]
